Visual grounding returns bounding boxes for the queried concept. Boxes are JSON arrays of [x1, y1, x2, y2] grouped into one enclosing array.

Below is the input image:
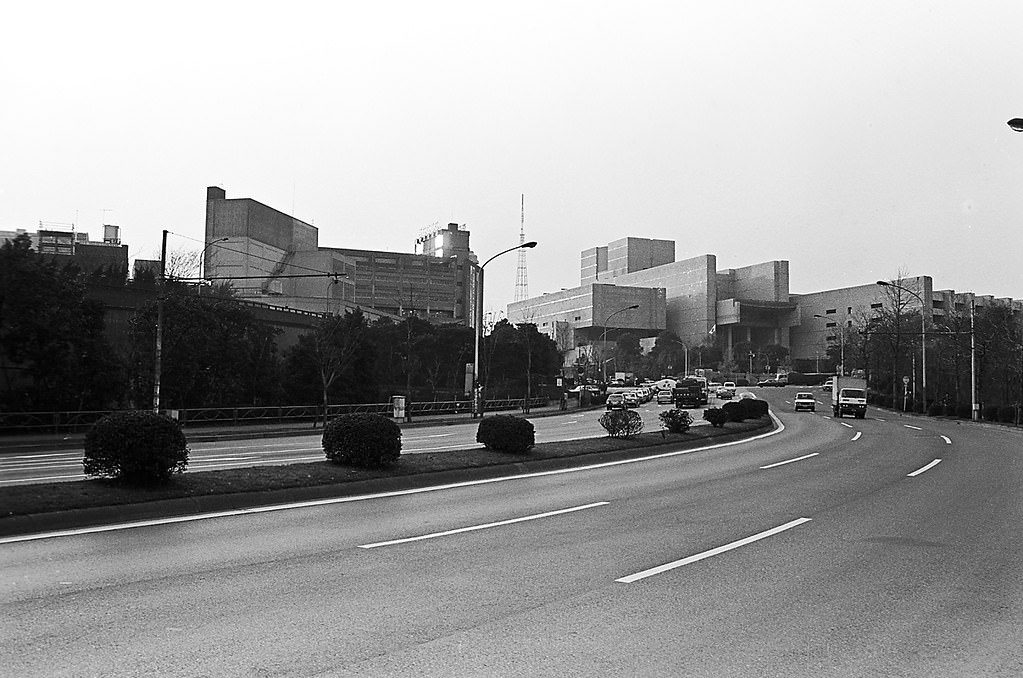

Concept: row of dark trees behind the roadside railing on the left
[[0, 237, 561, 411]]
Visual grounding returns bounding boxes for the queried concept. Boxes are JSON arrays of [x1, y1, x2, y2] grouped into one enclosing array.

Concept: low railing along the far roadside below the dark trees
[[0, 398, 548, 436]]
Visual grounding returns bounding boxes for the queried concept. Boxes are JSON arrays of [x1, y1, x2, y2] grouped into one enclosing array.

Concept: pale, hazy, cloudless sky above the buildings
[[0, 0, 1023, 310]]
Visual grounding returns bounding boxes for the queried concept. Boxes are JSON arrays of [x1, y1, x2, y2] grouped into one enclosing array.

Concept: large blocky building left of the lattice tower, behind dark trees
[[205, 186, 479, 325]]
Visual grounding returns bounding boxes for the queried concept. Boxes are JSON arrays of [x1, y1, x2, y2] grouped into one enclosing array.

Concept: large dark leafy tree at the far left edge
[[0, 235, 123, 411]]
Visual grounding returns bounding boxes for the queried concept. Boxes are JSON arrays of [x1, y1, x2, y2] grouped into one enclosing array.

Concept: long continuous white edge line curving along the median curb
[[0, 411, 785, 544]]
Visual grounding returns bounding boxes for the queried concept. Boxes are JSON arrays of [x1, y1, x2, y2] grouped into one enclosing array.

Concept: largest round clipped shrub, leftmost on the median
[[82, 410, 188, 485]]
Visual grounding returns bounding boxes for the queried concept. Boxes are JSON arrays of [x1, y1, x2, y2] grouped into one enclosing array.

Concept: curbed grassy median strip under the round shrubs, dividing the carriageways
[[0, 417, 774, 536]]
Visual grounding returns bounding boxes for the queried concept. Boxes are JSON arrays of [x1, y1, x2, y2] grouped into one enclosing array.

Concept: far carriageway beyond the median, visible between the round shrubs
[[0, 402, 707, 487]]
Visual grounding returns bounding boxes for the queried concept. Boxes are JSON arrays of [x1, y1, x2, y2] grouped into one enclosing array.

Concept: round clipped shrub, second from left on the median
[[323, 414, 401, 468]]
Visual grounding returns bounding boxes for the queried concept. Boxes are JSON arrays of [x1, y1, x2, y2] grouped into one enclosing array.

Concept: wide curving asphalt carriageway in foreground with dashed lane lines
[[0, 389, 1023, 677]]
